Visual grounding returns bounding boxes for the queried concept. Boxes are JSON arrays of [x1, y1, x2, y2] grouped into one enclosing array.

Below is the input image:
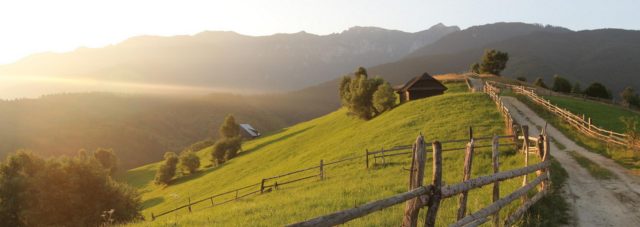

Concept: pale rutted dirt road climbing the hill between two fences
[[502, 97, 640, 226]]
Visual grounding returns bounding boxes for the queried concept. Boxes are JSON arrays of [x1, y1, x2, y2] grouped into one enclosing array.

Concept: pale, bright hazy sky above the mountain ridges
[[0, 0, 640, 64]]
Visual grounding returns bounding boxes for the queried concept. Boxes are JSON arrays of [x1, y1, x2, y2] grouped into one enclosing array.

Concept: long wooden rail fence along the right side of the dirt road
[[485, 82, 640, 148]]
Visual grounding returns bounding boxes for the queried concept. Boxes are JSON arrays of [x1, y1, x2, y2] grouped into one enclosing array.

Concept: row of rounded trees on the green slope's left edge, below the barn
[[154, 115, 242, 185]]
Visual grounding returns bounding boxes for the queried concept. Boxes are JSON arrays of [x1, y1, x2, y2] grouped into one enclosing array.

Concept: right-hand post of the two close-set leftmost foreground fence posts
[[424, 141, 442, 227]]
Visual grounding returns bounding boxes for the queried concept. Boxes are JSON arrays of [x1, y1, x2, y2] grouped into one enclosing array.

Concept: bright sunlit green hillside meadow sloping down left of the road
[[127, 86, 537, 226]]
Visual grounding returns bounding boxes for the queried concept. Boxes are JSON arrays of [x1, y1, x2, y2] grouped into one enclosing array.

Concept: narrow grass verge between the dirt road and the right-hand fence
[[514, 95, 640, 175]]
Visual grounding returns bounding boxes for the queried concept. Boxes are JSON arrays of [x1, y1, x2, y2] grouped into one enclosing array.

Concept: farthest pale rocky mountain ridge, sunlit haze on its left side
[[0, 24, 459, 92]]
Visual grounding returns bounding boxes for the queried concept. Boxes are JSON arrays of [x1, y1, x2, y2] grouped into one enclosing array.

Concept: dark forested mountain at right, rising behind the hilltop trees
[[370, 23, 640, 95]]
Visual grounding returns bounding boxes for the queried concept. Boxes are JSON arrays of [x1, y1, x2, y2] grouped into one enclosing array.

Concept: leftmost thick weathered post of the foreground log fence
[[402, 135, 426, 227]]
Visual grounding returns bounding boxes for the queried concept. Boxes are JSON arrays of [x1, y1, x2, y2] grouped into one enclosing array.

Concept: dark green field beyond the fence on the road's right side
[[544, 96, 640, 133]]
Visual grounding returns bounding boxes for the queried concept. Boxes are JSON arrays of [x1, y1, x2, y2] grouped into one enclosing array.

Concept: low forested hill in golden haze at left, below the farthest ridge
[[0, 90, 337, 168]]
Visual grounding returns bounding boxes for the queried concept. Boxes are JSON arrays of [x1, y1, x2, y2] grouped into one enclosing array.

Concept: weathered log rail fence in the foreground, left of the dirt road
[[289, 126, 550, 226]]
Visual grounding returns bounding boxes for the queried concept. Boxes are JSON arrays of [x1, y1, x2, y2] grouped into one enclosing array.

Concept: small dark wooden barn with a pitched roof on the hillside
[[394, 73, 447, 103]]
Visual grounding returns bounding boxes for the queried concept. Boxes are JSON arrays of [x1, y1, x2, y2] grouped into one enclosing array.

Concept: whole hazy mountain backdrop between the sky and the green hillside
[[0, 23, 640, 166]]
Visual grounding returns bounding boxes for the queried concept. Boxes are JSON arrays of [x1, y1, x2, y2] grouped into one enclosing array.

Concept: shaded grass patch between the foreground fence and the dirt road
[[518, 157, 573, 227]]
